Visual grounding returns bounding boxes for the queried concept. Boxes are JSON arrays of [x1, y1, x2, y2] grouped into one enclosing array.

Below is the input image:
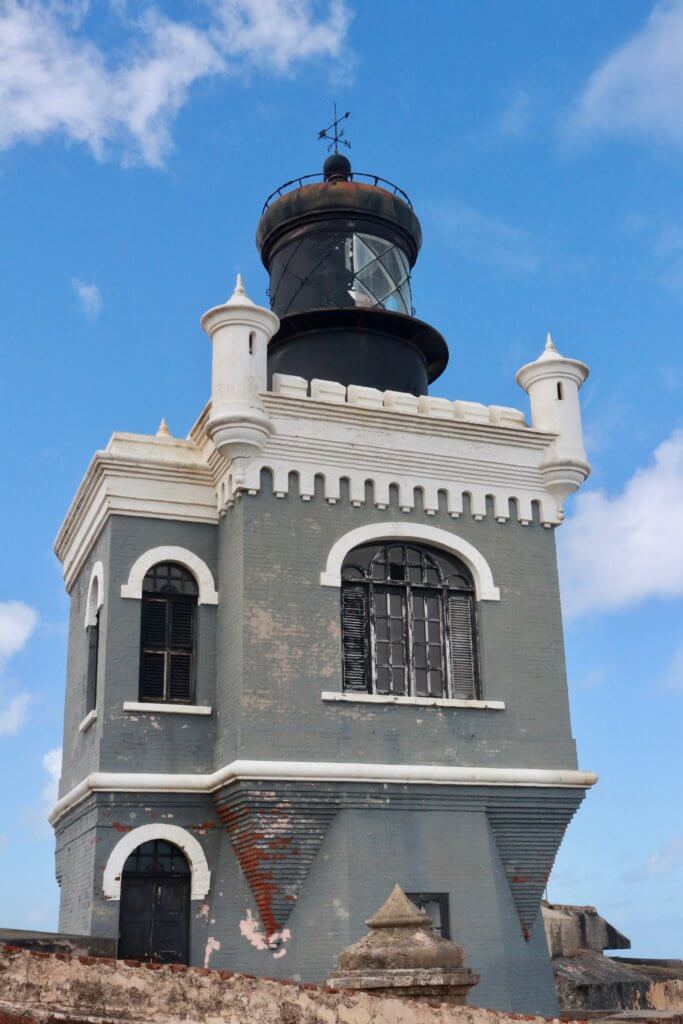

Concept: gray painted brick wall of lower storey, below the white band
[[58, 786, 585, 1015]]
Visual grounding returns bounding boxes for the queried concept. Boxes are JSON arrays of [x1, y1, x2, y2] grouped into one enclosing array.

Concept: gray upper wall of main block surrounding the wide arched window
[[223, 477, 577, 768]]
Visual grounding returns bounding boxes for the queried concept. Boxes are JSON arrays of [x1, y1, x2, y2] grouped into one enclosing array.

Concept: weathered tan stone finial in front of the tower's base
[[328, 885, 479, 1005]]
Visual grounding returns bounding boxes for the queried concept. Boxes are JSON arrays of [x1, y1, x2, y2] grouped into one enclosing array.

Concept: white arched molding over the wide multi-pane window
[[321, 522, 501, 601]]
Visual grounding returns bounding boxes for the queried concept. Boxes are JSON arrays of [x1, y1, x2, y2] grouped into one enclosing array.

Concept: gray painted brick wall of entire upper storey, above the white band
[[61, 479, 577, 793]]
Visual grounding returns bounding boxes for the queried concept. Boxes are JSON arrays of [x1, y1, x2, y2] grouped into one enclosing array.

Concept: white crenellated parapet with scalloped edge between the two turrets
[[205, 374, 581, 527]]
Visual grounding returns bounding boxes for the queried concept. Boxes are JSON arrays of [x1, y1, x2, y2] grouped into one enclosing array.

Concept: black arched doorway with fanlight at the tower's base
[[119, 839, 190, 964]]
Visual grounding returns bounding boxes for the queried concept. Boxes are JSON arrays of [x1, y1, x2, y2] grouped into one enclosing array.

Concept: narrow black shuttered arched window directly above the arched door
[[140, 562, 198, 703]]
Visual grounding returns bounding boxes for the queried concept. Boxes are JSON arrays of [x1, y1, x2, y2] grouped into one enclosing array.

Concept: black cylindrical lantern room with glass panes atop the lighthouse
[[256, 154, 449, 394]]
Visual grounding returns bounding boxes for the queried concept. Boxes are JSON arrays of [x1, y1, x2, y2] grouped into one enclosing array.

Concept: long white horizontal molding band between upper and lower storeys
[[48, 760, 598, 824]]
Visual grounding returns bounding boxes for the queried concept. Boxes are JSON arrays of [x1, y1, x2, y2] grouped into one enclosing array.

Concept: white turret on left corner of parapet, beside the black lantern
[[201, 274, 280, 460]]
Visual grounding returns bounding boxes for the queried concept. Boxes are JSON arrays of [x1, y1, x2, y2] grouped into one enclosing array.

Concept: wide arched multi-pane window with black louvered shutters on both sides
[[341, 543, 479, 699]]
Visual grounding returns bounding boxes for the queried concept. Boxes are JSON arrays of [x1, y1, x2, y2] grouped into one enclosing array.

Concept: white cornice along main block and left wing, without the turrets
[[54, 378, 588, 589]]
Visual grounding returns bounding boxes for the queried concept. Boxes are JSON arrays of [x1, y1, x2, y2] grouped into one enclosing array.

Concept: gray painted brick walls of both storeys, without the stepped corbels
[[57, 477, 589, 1014]]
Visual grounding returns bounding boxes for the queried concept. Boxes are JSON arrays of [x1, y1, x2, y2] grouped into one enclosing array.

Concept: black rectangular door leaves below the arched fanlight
[[119, 874, 189, 964]]
